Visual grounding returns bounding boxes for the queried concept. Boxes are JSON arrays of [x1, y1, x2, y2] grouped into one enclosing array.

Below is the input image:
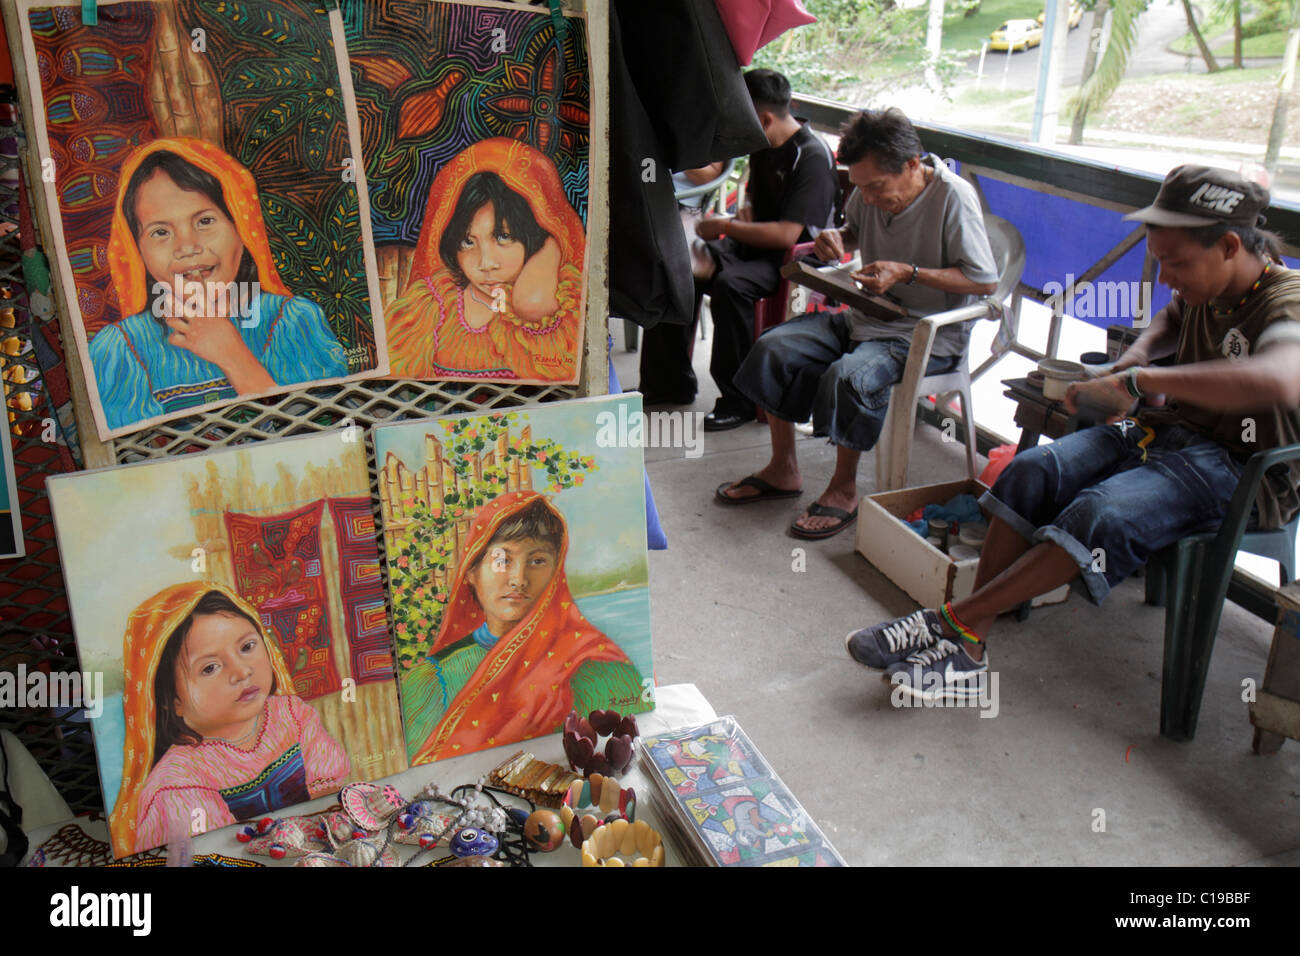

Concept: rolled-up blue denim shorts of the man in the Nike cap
[[980, 419, 1242, 604]]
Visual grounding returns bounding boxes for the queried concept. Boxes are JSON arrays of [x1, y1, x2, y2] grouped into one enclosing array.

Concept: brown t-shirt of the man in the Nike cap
[[1144, 264, 1300, 528]]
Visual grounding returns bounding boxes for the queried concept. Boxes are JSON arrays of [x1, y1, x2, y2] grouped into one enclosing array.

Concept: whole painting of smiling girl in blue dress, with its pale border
[[20, 0, 387, 440]]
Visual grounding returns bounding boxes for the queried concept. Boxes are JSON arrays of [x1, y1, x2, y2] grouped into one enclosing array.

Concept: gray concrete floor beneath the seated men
[[614, 321, 1300, 865]]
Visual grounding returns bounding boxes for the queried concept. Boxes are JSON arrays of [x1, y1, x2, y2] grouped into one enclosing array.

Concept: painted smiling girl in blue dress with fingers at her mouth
[[90, 137, 347, 429]]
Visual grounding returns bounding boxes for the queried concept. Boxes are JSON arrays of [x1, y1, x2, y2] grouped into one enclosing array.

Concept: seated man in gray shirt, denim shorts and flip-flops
[[718, 109, 998, 538]]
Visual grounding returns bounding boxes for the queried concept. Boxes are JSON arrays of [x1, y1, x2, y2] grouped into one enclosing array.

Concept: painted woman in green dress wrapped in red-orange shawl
[[402, 492, 642, 763]]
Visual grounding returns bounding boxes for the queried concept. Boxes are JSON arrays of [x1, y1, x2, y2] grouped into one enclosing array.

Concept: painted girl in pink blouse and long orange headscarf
[[109, 581, 350, 856]]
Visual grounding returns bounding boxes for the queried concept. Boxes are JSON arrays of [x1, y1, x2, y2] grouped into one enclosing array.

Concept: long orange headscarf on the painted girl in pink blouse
[[108, 581, 294, 856]]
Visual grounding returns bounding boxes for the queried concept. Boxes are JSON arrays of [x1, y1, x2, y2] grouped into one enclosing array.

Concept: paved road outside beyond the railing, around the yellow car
[[957, 0, 1227, 90]]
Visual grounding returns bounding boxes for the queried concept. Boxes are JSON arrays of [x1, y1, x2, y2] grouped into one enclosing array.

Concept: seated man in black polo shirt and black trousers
[[641, 70, 840, 432]]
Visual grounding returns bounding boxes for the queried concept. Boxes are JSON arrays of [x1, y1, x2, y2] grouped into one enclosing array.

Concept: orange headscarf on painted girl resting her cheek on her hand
[[410, 138, 586, 282]]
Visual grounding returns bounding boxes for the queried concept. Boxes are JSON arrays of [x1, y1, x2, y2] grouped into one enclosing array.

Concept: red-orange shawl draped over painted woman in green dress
[[411, 492, 631, 763]]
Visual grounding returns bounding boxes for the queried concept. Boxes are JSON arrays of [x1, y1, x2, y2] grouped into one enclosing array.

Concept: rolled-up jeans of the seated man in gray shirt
[[733, 312, 965, 451]]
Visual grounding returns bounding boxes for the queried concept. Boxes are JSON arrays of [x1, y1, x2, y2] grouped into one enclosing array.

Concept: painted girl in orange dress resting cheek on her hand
[[386, 138, 586, 384]]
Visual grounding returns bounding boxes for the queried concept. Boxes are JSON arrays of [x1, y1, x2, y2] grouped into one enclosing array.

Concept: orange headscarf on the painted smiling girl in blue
[[108, 137, 290, 319]]
